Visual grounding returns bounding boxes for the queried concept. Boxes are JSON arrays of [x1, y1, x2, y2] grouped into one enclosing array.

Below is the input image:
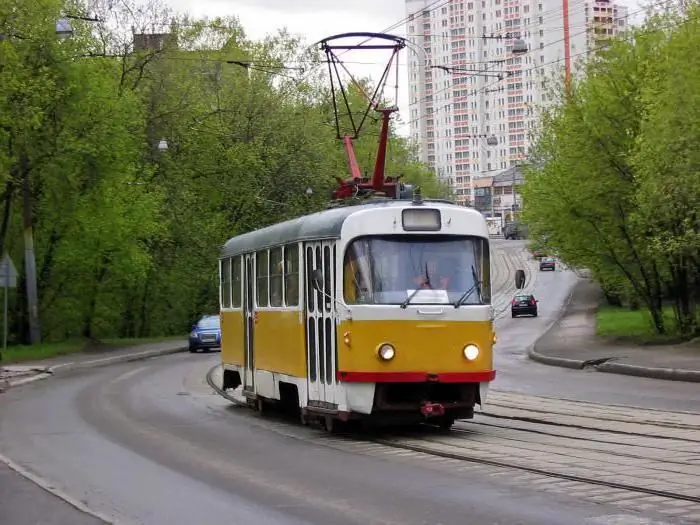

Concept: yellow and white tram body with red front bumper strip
[[220, 199, 496, 430]]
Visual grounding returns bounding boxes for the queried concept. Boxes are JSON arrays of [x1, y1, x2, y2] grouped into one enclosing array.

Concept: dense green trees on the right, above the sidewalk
[[523, 6, 700, 337]]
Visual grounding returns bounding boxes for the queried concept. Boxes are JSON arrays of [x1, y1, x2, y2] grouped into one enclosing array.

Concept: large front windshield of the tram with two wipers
[[343, 235, 491, 305]]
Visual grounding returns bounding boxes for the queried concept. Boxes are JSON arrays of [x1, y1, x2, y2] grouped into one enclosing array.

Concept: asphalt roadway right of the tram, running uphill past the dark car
[[492, 241, 700, 413]]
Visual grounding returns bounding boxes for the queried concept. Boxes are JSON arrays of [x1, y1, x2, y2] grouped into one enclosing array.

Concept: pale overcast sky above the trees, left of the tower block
[[157, 0, 639, 134]]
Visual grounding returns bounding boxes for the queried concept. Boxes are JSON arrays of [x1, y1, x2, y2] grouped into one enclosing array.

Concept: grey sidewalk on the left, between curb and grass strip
[[0, 339, 187, 392]]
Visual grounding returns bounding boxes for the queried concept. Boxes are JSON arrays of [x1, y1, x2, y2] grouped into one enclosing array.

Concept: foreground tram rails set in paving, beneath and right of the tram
[[207, 367, 700, 517]]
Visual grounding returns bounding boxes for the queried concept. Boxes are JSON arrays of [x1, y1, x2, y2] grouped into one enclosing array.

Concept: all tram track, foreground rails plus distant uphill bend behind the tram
[[207, 245, 700, 521]]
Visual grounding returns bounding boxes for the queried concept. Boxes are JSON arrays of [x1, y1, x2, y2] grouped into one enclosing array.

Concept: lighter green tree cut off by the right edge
[[632, 4, 700, 336]]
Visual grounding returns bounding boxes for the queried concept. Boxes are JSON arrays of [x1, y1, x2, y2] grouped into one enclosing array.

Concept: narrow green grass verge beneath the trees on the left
[[0, 335, 187, 365]]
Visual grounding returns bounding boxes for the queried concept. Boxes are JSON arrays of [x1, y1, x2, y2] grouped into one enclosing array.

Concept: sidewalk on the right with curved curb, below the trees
[[528, 280, 700, 382]]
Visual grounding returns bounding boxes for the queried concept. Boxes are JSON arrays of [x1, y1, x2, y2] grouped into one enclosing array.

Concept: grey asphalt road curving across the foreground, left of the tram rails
[[0, 355, 680, 525]]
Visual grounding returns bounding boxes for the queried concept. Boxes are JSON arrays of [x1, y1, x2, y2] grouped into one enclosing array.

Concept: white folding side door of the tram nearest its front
[[304, 241, 337, 405]]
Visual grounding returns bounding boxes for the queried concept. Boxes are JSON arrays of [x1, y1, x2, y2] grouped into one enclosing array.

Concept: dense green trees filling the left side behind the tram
[[0, 0, 444, 342]]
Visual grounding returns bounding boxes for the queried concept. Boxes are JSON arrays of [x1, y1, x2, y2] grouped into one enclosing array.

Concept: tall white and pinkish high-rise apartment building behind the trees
[[406, 0, 627, 204]]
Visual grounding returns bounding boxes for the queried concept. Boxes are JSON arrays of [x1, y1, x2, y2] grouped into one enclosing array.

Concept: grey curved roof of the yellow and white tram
[[221, 199, 465, 257]]
